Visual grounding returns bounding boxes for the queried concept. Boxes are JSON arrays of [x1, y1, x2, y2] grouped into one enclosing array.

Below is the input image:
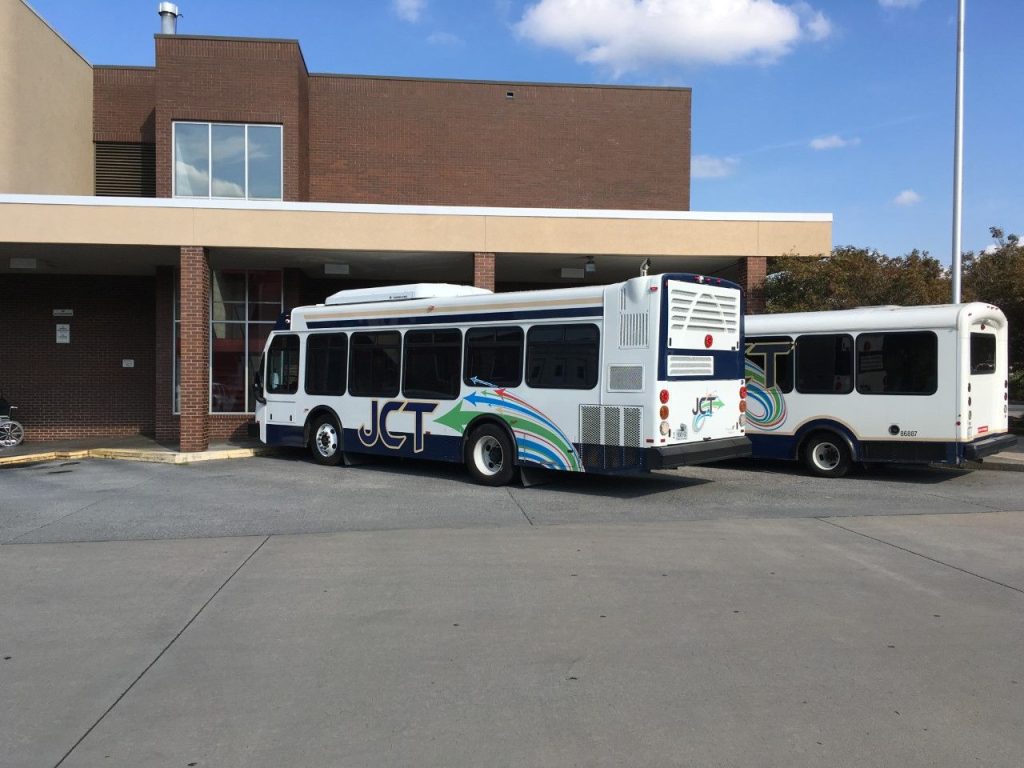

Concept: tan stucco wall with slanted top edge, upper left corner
[[0, 0, 94, 195]]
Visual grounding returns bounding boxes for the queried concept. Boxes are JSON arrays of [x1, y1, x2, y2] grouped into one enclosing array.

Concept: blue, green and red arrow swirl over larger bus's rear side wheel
[[434, 378, 584, 472]]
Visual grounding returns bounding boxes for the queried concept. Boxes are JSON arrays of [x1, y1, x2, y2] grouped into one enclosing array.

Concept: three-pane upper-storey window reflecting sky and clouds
[[172, 122, 284, 200]]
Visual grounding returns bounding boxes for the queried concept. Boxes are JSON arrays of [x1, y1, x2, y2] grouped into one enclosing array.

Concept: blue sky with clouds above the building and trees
[[30, 0, 1024, 263]]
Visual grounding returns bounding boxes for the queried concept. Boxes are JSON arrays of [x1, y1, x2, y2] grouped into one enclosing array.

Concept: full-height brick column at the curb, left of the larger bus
[[179, 246, 210, 452]]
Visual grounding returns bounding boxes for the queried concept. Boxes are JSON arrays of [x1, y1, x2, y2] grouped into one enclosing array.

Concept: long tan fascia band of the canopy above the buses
[[0, 203, 831, 257]]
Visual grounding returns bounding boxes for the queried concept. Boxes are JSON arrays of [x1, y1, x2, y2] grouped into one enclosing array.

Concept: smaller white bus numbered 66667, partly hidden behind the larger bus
[[745, 303, 1017, 477]]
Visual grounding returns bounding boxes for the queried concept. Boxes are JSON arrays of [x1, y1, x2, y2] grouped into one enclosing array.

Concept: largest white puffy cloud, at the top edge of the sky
[[516, 0, 831, 75]]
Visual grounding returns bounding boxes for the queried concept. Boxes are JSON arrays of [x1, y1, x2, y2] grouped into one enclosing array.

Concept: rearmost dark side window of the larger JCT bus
[[526, 325, 600, 389]]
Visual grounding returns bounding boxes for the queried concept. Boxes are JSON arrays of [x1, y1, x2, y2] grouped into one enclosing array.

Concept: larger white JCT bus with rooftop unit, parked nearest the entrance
[[253, 273, 751, 485]]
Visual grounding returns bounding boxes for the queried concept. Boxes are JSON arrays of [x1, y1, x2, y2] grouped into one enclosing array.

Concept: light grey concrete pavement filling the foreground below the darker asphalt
[[0, 513, 1024, 768]]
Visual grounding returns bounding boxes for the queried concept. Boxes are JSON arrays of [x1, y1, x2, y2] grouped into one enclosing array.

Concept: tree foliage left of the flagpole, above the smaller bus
[[765, 246, 952, 312]]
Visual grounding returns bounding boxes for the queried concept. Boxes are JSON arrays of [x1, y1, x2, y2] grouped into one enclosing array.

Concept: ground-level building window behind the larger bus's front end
[[210, 269, 284, 414]]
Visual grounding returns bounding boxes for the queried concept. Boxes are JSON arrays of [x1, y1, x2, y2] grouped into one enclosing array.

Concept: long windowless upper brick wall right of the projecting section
[[309, 75, 690, 210]]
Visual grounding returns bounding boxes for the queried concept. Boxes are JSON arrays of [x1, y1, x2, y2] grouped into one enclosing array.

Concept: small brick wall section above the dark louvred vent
[[92, 67, 157, 144]]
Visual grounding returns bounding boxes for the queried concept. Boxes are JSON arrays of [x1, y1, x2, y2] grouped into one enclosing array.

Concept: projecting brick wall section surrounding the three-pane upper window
[[150, 35, 308, 200]]
